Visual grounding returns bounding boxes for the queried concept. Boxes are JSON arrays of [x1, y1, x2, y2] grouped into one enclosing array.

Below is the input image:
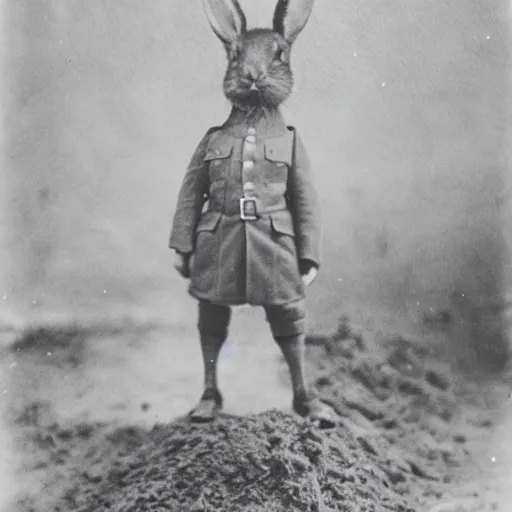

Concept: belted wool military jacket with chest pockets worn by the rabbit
[[169, 110, 320, 306]]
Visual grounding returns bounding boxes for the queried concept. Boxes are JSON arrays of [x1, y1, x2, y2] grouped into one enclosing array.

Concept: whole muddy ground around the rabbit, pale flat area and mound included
[[1, 318, 512, 512]]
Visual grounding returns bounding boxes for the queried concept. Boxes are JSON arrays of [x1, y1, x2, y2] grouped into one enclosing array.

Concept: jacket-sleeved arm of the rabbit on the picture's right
[[288, 132, 321, 275]]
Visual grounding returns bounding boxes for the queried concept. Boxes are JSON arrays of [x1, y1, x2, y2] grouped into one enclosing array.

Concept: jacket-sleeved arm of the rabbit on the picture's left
[[169, 129, 213, 255]]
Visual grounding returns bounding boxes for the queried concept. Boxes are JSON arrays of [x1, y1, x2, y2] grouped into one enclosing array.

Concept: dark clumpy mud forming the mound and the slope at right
[[8, 320, 508, 512]]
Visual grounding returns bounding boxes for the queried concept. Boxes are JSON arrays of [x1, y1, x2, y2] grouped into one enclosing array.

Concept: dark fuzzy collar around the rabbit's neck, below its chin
[[221, 108, 287, 138]]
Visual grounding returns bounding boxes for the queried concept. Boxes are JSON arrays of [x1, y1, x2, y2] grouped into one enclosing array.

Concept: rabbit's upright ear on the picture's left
[[203, 0, 247, 46]]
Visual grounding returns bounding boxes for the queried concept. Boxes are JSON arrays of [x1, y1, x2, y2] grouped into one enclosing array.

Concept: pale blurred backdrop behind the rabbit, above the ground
[[0, 0, 512, 360]]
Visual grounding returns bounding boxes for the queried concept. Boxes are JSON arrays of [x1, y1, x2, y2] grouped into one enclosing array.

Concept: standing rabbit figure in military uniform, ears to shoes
[[169, 0, 334, 426]]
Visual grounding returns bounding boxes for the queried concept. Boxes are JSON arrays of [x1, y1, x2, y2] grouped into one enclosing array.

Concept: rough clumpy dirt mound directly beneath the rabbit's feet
[[17, 411, 413, 512]]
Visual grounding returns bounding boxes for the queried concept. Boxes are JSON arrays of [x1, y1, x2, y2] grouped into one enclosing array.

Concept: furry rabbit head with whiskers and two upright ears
[[203, 0, 314, 110]]
